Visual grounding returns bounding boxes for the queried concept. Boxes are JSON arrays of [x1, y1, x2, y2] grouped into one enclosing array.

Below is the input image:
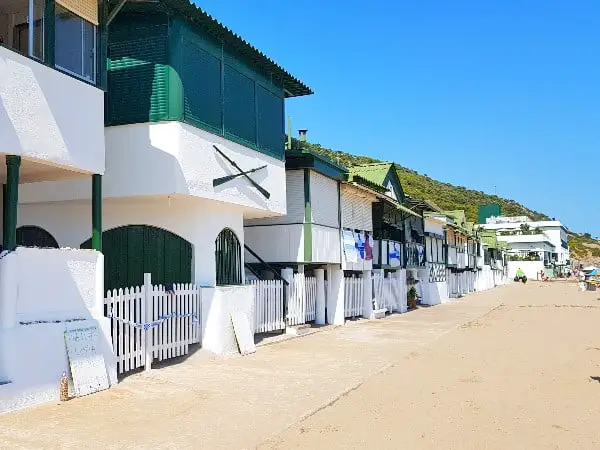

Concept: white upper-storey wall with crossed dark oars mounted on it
[[20, 122, 286, 217]]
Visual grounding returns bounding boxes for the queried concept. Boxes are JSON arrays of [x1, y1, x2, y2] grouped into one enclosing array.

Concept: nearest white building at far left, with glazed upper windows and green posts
[[0, 0, 116, 411]]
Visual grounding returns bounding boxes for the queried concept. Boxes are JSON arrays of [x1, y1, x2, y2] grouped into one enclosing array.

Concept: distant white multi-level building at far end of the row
[[479, 216, 570, 266]]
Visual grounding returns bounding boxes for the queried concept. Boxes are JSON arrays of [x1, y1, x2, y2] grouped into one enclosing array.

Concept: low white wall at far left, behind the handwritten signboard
[[0, 247, 117, 411]]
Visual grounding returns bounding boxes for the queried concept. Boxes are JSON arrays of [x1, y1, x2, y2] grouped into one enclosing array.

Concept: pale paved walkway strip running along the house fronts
[[0, 284, 536, 449]]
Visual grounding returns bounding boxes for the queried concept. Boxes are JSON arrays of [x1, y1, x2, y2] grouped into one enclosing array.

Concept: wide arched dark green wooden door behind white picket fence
[[81, 225, 192, 290]]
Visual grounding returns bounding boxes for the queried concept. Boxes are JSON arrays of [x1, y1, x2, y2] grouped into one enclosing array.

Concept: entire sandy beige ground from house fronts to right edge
[[0, 282, 600, 449]]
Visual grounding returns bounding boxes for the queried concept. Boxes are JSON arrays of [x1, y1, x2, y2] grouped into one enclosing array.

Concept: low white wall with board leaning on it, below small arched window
[[200, 286, 254, 355]]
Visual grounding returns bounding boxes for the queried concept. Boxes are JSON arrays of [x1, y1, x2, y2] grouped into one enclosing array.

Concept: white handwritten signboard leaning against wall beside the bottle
[[65, 326, 109, 397]]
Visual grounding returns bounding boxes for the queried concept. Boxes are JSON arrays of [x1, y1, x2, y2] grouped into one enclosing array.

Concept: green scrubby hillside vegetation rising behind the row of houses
[[294, 140, 600, 264]]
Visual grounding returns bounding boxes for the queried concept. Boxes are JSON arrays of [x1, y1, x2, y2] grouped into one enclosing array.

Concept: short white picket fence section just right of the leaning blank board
[[250, 280, 285, 333]]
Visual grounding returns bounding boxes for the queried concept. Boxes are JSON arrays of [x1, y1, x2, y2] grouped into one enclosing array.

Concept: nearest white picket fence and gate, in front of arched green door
[[104, 274, 201, 374]]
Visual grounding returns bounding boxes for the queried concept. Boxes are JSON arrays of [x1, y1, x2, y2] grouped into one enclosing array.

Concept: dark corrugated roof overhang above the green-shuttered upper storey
[[159, 0, 313, 97]]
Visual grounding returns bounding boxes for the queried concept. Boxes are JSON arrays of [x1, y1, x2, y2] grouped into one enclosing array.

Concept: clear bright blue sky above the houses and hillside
[[200, 0, 600, 235]]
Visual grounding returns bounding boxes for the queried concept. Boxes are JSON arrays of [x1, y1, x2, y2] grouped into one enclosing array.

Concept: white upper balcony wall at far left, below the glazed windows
[[0, 47, 104, 176]]
